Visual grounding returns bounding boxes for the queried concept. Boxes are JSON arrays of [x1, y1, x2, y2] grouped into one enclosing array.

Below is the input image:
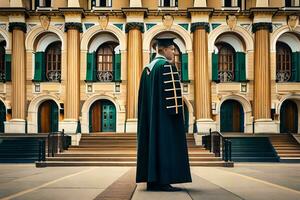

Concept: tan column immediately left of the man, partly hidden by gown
[[126, 22, 144, 132]]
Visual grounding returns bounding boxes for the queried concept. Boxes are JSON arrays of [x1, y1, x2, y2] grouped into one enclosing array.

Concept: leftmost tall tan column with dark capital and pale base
[[5, 22, 26, 133]]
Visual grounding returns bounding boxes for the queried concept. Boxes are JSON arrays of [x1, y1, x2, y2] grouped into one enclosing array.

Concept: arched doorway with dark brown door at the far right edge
[[280, 100, 298, 133]]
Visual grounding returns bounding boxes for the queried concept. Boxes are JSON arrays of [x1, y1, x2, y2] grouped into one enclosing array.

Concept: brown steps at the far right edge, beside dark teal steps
[[270, 134, 300, 162]]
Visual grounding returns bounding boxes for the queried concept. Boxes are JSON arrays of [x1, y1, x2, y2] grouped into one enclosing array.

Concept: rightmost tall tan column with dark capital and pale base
[[252, 22, 277, 133]]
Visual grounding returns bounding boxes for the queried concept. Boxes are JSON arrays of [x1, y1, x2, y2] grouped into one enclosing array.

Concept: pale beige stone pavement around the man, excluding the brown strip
[[0, 163, 300, 200]]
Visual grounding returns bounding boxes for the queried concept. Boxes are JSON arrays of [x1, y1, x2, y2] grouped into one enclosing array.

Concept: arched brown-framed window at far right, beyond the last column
[[276, 42, 292, 82]]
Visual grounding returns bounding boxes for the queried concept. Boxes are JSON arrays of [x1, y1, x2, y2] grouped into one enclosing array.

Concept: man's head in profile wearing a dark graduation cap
[[156, 38, 175, 62]]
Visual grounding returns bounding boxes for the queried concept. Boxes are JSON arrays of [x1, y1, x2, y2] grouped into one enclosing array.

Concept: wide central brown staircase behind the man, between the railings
[[36, 133, 233, 167]]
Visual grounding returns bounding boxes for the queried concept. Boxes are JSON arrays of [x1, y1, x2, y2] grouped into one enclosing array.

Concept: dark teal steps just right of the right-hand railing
[[230, 136, 279, 162]]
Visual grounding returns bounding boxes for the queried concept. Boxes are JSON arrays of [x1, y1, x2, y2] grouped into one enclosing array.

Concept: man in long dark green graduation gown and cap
[[136, 38, 192, 191]]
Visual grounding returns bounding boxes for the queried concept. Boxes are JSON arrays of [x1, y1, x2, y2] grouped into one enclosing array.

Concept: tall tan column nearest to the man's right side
[[191, 22, 214, 132]]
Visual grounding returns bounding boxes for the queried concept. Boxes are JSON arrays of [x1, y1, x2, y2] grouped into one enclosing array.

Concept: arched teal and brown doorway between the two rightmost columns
[[221, 100, 244, 132]]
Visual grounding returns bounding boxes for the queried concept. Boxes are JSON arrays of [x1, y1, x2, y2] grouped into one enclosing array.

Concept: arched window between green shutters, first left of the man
[[96, 42, 117, 82]]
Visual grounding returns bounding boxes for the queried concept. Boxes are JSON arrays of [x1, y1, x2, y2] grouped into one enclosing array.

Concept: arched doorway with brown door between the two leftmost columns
[[38, 100, 59, 133]]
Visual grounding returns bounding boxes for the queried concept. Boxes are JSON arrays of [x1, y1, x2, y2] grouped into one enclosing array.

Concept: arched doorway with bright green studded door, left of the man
[[89, 100, 116, 133]]
